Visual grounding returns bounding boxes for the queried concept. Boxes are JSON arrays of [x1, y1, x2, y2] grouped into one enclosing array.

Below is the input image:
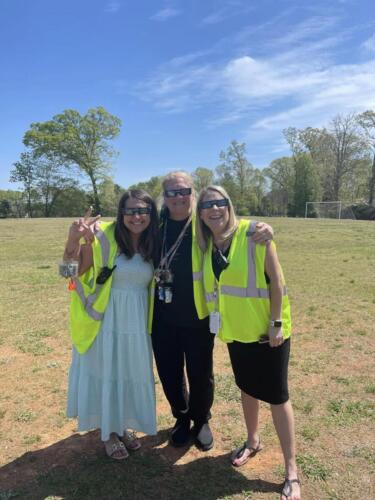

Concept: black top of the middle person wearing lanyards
[[154, 219, 208, 328]]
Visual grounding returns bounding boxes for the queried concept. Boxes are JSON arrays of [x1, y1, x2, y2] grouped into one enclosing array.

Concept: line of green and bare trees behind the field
[[0, 107, 375, 219]]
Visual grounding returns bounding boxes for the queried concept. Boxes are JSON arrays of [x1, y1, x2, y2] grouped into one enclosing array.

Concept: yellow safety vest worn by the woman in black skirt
[[203, 220, 291, 343]]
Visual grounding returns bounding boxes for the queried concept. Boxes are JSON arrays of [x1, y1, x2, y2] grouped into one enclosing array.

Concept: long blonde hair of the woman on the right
[[195, 186, 238, 252]]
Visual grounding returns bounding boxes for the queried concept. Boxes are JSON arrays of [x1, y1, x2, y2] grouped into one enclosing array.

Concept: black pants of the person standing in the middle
[[151, 318, 214, 425]]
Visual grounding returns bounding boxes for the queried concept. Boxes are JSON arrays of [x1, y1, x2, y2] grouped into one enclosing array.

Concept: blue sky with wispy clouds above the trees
[[0, 0, 375, 189]]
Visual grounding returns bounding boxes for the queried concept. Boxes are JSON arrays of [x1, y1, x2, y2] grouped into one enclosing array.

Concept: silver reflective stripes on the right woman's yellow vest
[[205, 221, 287, 302]]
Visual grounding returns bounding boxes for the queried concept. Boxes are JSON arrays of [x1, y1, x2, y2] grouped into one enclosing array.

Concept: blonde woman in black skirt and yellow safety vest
[[196, 186, 300, 500]]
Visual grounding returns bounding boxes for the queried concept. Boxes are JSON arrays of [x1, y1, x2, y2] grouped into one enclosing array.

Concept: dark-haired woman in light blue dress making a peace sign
[[64, 190, 159, 460]]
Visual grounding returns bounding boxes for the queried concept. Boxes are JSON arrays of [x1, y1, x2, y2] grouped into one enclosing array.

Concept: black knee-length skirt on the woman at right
[[228, 339, 290, 405]]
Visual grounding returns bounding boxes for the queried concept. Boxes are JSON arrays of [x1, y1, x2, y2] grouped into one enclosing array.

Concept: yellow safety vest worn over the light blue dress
[[70, 222, 117, 354]]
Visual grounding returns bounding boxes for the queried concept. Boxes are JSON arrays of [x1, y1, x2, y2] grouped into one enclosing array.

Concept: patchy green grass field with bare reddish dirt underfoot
[[0, 218, 375, 500]]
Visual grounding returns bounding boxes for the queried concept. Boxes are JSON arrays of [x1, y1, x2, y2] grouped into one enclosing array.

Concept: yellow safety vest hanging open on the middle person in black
[[148, 214, 208, 333]]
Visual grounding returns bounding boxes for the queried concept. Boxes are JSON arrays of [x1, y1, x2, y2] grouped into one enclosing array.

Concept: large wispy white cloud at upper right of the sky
[[138, 17, 375, 136]]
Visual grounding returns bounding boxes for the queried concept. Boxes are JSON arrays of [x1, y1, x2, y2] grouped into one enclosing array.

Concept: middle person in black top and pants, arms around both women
[[152, 172, 272, 451]]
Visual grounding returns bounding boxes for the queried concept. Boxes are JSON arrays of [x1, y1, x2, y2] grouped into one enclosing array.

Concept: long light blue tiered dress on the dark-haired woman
[[67, 254, 156, 441]]
